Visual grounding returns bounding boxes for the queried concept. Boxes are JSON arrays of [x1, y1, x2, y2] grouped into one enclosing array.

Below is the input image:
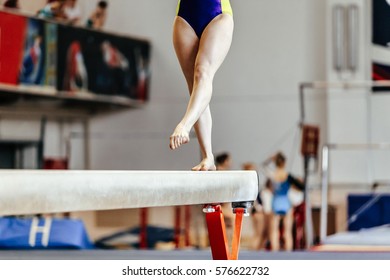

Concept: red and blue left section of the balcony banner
[[0, 11, 57, 93]]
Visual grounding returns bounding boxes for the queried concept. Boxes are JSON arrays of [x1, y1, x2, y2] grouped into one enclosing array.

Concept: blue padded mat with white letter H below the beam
[[0, 217, 94, 249]]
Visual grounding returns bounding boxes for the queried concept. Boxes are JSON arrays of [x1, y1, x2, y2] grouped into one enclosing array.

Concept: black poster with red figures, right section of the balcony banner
[[57, 25, 150, 101]]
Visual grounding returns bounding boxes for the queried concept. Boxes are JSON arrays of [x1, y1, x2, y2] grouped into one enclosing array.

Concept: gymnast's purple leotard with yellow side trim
[[177, 0, 233, 38]]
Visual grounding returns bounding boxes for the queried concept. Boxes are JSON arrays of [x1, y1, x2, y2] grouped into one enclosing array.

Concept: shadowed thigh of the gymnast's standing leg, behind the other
[[173, 16, 199, 88]]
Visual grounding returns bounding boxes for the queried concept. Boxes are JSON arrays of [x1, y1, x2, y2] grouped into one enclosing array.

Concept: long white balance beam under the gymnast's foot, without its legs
[[0, 170, 259, 216]]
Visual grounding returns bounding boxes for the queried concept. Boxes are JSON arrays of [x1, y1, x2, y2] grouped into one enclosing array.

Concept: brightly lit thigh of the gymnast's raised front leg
[[195, 14, 234, 75]]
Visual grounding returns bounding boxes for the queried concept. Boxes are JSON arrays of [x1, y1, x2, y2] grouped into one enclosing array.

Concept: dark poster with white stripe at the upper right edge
[[372, 0, 390, 91]]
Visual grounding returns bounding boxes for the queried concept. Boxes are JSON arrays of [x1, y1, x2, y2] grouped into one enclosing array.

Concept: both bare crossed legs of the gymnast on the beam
[[170, 14, 234, 170]]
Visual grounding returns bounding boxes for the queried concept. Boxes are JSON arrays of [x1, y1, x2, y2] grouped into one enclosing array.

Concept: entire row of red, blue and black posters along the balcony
[[0, 11, 150, 102]]
